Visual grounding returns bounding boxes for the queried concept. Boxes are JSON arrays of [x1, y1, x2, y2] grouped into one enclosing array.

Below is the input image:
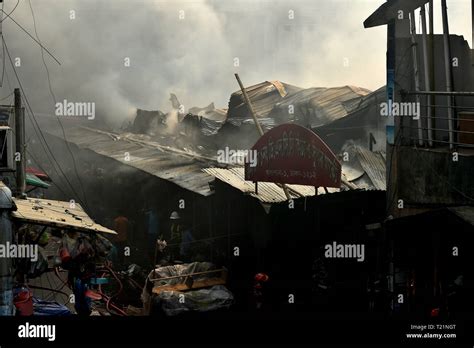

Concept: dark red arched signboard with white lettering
[[245, 124, 341, 188]]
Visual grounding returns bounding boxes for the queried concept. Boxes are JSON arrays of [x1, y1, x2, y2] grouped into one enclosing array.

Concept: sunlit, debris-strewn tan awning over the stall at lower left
[[12, 198, 116, 234]]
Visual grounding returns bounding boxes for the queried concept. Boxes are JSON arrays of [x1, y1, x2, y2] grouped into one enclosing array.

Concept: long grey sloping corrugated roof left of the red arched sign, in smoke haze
[[48, 127, 215, 196]]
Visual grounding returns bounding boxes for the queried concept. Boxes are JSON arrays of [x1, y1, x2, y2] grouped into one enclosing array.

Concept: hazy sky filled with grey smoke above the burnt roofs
[[0, 0, 472, 126]]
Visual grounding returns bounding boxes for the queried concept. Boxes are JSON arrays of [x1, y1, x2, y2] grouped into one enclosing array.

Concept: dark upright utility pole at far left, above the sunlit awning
[[14, 88, 26, 197]]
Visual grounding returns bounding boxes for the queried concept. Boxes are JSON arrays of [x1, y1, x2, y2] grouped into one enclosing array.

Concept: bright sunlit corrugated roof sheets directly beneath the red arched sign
[[203, 167, 339, 203]]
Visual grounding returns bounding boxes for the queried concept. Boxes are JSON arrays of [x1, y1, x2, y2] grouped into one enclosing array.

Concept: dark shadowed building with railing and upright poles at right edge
[[364, 0, 474, 318]]
